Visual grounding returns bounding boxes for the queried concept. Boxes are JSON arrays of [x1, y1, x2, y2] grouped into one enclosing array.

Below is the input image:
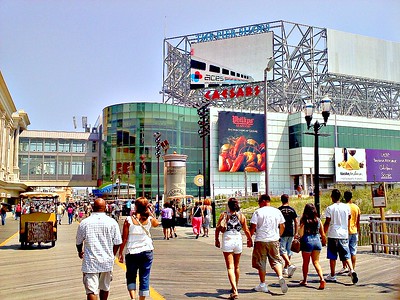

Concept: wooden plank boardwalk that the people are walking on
[[0, 219, 400, 300]]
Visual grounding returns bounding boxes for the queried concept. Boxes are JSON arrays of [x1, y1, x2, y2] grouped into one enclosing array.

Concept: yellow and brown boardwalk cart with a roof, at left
[[19, 192, 58, 249]]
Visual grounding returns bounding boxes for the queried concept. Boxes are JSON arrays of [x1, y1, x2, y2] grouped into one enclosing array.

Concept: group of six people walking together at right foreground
[[215, 189, 361, 299]]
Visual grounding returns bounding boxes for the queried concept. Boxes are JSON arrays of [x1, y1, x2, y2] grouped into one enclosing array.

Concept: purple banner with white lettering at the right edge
[[365, 149, 400, 182]]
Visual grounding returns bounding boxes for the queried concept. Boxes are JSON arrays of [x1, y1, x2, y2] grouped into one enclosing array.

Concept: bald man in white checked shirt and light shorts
[[76, 198, 122, 300]]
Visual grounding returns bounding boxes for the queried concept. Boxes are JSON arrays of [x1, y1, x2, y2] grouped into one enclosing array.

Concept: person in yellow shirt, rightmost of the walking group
[[338, 191, 361, 274]]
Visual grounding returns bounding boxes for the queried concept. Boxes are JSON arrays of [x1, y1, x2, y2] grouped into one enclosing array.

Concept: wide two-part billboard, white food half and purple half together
[[335, 148, 400, 182]]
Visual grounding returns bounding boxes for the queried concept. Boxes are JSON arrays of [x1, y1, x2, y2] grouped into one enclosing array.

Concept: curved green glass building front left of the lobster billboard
[[100, 102, 203, 199]]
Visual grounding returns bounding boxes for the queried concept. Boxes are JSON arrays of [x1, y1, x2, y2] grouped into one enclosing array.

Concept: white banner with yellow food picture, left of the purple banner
[[335, 148, 368, 182]]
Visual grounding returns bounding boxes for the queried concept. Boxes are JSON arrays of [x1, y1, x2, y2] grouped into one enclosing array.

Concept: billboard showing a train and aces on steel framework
[[190, 32, 273, 89]]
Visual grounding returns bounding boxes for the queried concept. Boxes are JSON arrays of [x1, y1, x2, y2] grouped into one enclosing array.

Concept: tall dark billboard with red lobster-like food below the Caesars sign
[[218, 111, 266, 172]]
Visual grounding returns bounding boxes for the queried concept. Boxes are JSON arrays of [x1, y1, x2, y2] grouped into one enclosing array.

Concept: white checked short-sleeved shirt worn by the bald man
[[76, 212, 122, 273]]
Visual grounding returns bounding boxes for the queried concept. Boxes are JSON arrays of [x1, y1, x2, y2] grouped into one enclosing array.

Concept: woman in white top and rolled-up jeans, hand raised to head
[[119, 197, 159, 300]]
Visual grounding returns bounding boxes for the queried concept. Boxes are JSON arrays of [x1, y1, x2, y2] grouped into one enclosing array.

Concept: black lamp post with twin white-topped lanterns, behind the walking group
[[305, 96, 331, 216]]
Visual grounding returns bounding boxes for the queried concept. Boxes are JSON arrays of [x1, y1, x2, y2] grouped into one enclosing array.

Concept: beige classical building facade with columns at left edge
[[0, 72, 30, 204]]
